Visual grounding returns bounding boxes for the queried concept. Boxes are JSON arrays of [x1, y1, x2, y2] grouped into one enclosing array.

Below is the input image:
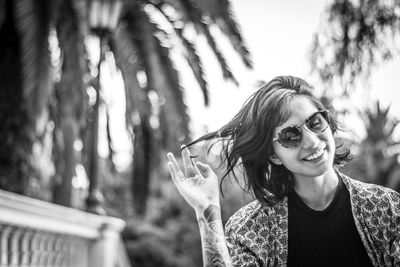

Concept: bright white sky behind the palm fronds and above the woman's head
[[99, 0, 400, 171]]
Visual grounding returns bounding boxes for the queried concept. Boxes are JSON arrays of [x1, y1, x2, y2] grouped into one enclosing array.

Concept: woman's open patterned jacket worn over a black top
[[225, 174, 400, 266]]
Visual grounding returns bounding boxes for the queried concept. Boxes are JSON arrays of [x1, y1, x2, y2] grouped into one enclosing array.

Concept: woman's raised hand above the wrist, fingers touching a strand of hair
[[167, 147, 219, 212]]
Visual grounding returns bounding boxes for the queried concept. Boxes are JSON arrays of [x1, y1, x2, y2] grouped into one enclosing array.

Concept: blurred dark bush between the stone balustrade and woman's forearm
[[125, 182, 202, 267]]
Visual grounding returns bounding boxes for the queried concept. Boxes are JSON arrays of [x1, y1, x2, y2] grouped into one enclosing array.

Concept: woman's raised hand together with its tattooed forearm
[[167, 147, 232, 266]]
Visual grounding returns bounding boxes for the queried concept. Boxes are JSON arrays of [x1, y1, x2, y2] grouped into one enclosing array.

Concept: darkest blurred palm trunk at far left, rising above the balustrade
[[0, 1, 52, 198]]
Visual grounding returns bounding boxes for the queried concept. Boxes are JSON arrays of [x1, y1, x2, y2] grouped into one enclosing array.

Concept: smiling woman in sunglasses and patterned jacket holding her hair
[[168, 76, 400, 266]]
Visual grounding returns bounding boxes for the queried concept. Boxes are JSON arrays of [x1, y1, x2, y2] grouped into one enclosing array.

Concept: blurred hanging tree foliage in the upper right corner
[[311, 0, 400, 94]]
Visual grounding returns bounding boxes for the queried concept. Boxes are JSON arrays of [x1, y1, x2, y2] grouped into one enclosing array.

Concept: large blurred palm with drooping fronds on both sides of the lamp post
[[0, 0, 252, 214]]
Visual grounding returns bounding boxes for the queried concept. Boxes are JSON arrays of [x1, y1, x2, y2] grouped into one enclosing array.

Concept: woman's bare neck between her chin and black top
[[294, 168, 339, 210]]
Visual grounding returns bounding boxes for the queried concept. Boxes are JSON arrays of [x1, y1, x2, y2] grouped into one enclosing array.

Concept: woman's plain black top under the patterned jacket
[[288, 179, 372, 267]]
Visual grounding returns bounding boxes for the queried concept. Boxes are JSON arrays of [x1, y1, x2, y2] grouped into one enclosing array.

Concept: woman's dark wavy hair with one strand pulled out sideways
[[187, 76, 350, 205]]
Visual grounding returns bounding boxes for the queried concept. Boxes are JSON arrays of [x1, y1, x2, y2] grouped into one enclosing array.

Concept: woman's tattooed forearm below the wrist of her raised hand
[[196, 205, 232, 266]]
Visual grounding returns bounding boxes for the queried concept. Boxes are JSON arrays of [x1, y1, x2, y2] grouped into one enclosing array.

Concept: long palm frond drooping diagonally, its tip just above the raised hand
[[122, 5, 189, 151]]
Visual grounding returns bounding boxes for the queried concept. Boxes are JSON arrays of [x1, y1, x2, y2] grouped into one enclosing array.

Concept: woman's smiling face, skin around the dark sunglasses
[[271, 96, 335, 179]]
